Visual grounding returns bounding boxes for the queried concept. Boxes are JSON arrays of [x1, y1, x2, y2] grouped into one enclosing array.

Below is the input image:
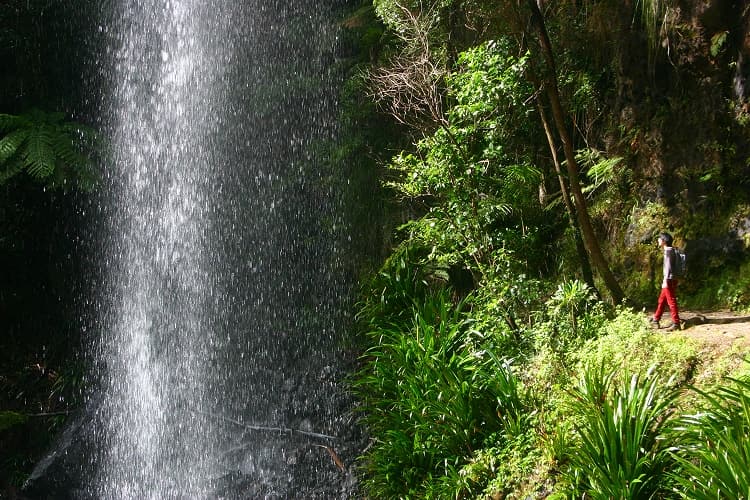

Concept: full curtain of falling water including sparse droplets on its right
[[25, 0, 362, 499]]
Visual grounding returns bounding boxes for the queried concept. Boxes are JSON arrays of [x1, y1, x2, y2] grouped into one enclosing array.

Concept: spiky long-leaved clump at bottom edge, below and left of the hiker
[[566, 366, 679, 499]]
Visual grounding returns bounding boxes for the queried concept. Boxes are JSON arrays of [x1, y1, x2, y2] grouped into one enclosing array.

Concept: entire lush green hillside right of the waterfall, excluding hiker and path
[[345, 0, 750, 499]]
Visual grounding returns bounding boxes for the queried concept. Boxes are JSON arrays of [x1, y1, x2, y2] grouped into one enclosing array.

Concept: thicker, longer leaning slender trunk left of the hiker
[[527, 0, 624, 304]]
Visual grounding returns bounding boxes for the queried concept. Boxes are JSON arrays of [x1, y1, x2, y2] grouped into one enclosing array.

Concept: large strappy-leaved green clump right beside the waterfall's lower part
[[354, 289, 523, 498]]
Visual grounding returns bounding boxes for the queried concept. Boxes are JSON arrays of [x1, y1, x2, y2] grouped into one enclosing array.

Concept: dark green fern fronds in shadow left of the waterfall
[[0, 109, 95, 189]]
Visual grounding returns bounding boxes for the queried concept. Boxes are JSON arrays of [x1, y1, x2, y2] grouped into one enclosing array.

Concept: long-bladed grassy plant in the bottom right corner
[[675, 378, 750, 500]]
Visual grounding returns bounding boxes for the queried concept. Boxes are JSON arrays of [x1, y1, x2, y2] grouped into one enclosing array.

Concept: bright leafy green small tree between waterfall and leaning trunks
[[387, 42, 542, 284]]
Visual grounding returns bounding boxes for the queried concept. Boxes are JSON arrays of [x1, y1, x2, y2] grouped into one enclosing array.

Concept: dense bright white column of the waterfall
[[93, 1, 223, 499]]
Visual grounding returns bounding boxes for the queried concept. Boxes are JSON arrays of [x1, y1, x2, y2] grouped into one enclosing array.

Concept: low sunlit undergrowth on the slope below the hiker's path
[[354, 276, 750, 499]]
